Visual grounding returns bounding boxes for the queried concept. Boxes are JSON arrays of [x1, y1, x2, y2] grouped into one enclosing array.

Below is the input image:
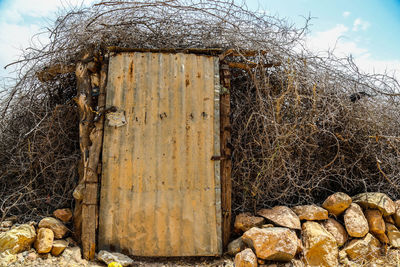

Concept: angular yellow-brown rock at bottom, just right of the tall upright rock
[[343, 233, 380, 261]]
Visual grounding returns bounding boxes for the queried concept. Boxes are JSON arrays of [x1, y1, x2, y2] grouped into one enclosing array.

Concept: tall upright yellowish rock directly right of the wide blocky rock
[[302, 222, 339, 266]]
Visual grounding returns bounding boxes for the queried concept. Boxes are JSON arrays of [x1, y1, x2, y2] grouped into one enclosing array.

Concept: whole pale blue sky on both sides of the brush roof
[[0, 0, 400, 77]]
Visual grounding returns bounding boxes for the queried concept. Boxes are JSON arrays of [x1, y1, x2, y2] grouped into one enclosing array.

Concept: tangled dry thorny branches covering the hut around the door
[[0, 0, 400, 222]]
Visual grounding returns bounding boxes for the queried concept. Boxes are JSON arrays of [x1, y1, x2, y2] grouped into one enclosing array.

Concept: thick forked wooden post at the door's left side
[[76, 51, 108, 260]]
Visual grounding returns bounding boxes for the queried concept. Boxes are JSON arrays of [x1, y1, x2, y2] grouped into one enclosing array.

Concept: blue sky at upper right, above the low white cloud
[[247, 0, 400, 60]]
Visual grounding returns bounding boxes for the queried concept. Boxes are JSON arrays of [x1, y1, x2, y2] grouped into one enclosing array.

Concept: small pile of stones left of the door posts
[[0, 209, 72, 264]]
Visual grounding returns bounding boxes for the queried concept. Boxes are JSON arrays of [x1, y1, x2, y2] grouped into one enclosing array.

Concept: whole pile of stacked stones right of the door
[[228, 192, 400, 267]]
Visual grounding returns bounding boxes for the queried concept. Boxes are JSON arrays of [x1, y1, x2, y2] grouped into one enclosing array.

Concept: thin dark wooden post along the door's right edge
[[220, 62, 232, 248]]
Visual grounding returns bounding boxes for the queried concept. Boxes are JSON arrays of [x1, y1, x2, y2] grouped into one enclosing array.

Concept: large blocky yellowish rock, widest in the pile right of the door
[[242, 227, 298, 261]]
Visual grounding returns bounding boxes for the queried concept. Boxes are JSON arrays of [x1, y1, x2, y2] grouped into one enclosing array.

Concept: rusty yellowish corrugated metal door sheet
[[99, 52, 222, 256]]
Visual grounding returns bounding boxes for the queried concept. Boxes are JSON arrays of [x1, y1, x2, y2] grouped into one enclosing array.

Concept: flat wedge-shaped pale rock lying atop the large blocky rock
[[257, 206, 301, 230]]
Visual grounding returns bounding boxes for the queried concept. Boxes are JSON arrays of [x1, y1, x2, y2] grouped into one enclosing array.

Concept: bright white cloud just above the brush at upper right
[[306, 24, 400, 78]]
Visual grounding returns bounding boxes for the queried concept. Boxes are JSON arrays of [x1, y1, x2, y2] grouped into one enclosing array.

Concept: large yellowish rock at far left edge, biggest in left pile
[[0, 224, 36, 254]]
